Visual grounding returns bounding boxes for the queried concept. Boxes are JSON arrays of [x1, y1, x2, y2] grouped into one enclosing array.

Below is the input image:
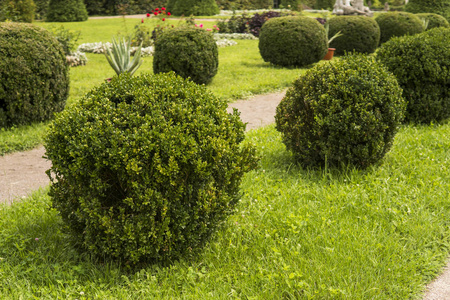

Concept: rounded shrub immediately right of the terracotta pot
[[328, 16, 380, 55]]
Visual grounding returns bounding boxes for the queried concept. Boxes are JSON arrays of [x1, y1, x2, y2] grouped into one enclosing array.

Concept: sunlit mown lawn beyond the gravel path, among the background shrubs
[[0, 18, 305, 155]]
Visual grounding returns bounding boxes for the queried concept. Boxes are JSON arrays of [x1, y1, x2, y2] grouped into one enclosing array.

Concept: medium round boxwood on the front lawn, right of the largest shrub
[[275, 54, 405, 168]]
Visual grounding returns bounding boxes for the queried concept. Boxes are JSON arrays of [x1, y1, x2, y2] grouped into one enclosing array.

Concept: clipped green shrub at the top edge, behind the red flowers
[[167, 0, 219, 16]]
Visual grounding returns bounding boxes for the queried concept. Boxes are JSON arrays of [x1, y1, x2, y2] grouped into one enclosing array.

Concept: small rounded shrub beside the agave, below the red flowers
[[153, 26, 219, 84]]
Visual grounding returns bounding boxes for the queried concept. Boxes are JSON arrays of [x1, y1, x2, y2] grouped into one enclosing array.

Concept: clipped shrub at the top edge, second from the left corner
[[45, 0, 88, 22]]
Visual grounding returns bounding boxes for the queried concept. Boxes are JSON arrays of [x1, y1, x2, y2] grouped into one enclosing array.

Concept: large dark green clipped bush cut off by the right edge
[[377, 28, 450, 123]]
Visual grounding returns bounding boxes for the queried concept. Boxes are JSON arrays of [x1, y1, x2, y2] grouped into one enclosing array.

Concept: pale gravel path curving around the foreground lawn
[[0, 92, 450, 300]]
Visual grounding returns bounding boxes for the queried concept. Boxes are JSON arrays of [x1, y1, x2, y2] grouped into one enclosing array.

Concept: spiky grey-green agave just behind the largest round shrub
[[104, 37, 142, 75]]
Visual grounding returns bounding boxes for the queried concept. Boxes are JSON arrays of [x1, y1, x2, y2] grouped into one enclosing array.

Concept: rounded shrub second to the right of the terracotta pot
[[375, 12, 423, 44]]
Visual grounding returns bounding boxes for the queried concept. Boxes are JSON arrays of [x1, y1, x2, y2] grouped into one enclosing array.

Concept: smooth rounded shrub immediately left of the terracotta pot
[[259, 17, 328, 67]]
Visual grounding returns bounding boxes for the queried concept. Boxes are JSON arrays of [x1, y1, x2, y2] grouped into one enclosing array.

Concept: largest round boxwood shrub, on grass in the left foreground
[[45, 73, 256, 263]]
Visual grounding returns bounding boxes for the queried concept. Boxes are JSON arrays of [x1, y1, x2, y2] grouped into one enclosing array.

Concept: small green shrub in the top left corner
[[0, 0, 35, 23]]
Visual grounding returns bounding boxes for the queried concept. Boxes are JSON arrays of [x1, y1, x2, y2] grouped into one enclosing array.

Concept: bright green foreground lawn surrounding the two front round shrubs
[[0, 123, 450, 299]]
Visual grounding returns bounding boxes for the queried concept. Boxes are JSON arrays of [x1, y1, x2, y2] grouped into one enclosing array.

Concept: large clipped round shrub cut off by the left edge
[[0, 23, 69, 128]]
